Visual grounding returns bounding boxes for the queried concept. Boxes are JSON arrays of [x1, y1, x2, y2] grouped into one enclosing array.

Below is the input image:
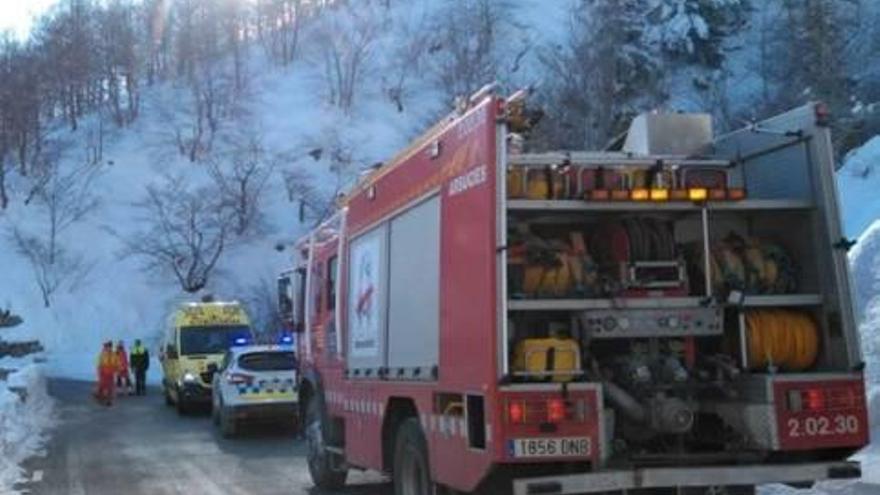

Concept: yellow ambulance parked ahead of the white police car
[[159, 301, 253, 414]]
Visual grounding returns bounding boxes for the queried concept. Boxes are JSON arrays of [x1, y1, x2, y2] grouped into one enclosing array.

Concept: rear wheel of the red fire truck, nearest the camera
[[394, 418, 436, 495]]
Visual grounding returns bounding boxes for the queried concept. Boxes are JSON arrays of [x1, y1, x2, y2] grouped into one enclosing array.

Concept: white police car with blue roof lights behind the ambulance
[[211, 345, 299, 437]]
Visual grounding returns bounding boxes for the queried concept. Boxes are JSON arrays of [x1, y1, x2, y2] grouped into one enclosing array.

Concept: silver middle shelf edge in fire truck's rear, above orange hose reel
[[507, 294, 822, 311]]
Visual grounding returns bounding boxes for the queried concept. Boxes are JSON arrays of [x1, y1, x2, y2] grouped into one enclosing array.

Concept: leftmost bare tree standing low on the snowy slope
[[8, 142, 99, 307]]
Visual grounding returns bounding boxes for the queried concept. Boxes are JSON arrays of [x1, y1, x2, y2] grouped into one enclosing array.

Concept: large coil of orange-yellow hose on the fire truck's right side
[[746, 309, 819, 371]]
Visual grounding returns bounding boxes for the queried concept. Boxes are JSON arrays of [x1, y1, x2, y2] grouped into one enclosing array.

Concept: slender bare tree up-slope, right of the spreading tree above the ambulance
[[207, 134, 278, 238]]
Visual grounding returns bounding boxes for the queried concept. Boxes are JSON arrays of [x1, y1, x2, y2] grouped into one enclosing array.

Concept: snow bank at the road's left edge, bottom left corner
[[0, 360, 54, 494]]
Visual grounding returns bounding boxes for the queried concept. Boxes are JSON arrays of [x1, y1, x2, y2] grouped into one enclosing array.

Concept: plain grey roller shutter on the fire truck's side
[[388, 195, 440, 378]]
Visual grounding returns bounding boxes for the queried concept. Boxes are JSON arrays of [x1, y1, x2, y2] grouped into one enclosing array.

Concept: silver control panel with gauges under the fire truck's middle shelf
[[581, 308, 724, 339]]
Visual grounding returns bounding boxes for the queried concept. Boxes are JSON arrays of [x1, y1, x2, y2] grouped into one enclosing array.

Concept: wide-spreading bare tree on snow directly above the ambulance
[[123, 177, 235, 293]]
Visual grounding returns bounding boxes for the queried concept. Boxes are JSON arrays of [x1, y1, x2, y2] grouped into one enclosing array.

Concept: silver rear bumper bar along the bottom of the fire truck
[[513, 462, 861, 495]]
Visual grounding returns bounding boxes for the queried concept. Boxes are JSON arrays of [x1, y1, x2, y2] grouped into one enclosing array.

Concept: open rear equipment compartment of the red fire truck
[[506, 103, 867, 466]]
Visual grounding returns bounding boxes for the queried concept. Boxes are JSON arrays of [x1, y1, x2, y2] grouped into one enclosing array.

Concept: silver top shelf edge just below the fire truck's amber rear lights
[[507, 199, 813, 212]]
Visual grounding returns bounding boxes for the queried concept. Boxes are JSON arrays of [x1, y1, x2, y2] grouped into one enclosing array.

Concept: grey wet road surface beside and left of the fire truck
[[20, 380, 390, 495]]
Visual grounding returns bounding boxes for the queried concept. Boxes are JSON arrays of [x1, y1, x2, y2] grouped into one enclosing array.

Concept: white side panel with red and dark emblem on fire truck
[[346, 223, 388, 371]]
